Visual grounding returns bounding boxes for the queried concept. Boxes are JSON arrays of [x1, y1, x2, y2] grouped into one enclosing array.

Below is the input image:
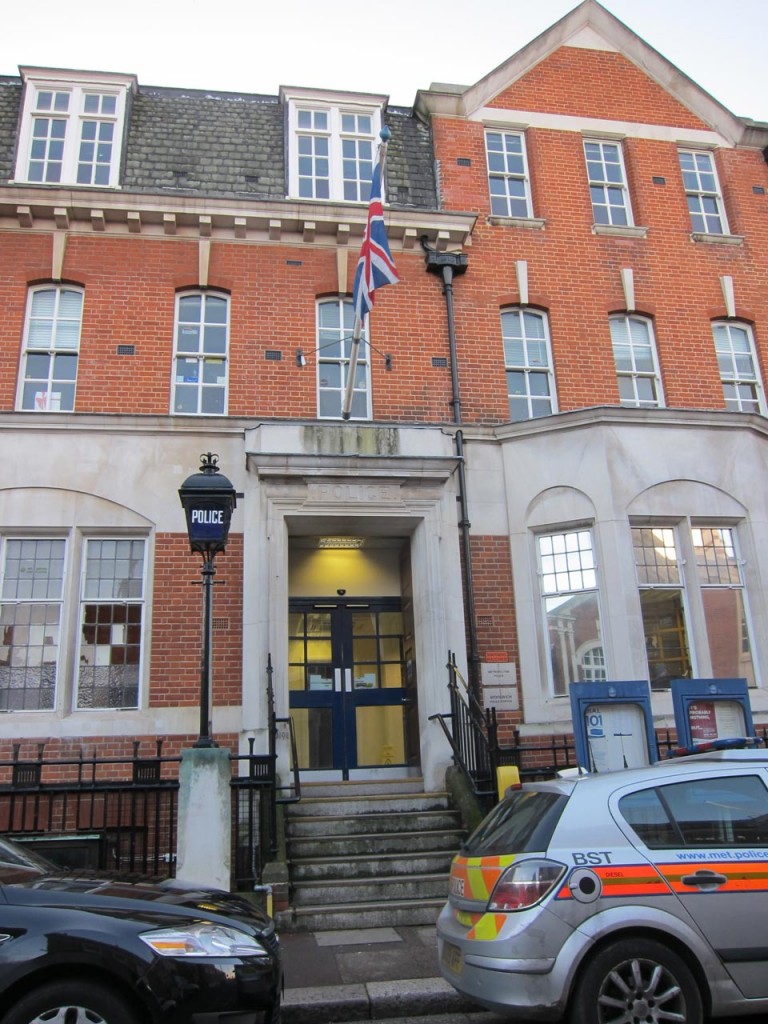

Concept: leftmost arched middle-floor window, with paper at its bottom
[[18, 285, 83, 413]]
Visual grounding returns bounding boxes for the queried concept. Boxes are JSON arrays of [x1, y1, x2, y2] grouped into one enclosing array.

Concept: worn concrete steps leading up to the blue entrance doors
[[276, 779, 465, 932]]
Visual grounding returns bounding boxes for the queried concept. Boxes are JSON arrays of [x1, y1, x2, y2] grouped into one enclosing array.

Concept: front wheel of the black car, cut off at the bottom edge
[[2, 981, 138, 1024]]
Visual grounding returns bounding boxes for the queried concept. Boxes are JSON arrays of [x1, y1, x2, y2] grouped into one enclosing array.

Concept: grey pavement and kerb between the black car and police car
[[280, 926, 501, 1024]]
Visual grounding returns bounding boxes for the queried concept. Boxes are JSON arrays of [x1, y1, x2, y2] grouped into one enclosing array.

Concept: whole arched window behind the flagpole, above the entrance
[[317, 299, 371, 420]]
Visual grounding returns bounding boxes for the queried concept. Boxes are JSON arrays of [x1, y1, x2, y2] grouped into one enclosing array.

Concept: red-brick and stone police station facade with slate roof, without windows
[[0, 4, 768, 782]]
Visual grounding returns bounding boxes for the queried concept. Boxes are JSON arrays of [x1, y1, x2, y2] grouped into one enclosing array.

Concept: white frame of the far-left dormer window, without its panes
[[14, 68, 136, 188]]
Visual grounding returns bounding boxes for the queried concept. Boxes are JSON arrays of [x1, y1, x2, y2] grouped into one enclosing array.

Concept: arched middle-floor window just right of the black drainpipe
[[502, 308, 557, 420]]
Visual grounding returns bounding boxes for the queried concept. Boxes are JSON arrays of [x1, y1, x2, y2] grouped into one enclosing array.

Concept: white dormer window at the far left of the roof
[[15, 68, 135, 187]]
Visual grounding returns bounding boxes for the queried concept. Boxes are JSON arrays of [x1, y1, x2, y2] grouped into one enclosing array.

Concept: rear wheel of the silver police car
[[569, 938, 703, 1024]]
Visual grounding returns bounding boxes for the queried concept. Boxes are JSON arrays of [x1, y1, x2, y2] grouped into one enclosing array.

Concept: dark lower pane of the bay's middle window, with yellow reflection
[[640, 590, 691, 689]]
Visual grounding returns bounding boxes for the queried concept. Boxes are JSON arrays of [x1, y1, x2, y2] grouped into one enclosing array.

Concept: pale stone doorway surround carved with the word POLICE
[[243, 422, 466, 791]]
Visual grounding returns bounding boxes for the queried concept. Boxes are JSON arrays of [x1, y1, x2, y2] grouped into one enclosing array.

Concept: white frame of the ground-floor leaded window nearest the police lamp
[[73, 534, 148, 712]]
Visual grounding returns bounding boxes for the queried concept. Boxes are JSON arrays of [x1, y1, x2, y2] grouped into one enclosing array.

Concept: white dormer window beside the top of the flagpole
[[282, 89, 384, 203]]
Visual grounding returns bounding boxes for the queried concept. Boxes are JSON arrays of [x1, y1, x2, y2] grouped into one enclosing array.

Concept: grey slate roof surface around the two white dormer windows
[[0, 78, 437, 210]]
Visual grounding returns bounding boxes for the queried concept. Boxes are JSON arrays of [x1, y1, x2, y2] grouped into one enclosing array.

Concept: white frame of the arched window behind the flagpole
[[315, 297, 373, 422]]
